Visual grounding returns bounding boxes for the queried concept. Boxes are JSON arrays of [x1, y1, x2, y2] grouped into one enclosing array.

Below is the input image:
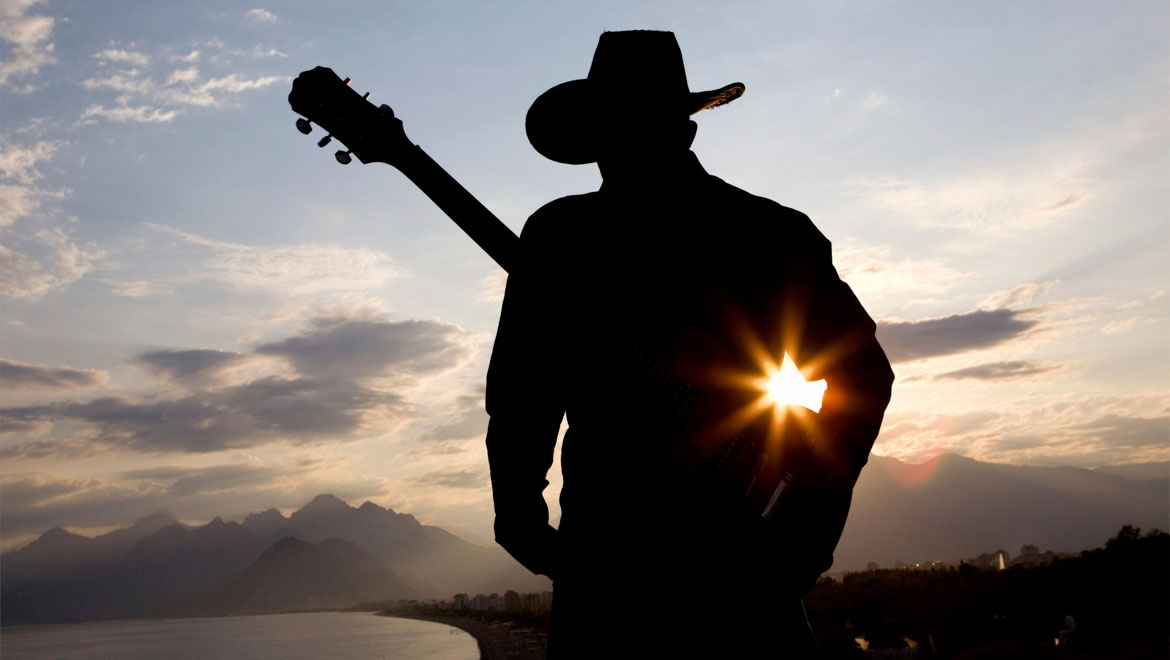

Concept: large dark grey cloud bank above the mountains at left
[[0, 311, 474, 458]]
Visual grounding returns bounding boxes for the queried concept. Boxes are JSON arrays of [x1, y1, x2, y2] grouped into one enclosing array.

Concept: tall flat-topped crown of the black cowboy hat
[[587, 29, 690, 104]]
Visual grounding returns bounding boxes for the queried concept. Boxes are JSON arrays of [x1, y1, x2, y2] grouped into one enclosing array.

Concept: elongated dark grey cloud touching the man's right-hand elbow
[[878, 309, 1037, 362]]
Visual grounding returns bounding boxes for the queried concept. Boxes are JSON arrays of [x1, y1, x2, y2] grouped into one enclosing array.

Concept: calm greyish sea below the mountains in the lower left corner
[[0, 612, 480, 660]]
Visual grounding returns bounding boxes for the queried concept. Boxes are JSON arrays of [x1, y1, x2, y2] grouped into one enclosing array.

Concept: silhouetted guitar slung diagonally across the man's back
[[289, 67, 828, 536]]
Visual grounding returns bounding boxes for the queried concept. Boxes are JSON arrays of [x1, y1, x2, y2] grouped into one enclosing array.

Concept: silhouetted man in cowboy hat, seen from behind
[[487, 32, 893, 659]]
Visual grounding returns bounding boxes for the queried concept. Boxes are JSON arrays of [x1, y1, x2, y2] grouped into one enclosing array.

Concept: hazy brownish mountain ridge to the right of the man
[[832, 454, 1170, 571]]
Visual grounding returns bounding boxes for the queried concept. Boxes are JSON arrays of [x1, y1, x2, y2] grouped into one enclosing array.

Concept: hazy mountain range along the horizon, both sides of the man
[[0, 454, 1170, 625]]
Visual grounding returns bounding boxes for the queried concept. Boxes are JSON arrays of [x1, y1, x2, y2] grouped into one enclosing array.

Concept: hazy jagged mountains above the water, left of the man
[[0, 495, 550, 624]]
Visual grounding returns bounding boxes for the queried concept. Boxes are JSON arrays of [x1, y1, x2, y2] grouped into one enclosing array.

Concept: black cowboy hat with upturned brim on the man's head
[[524, 30, 744, 165]]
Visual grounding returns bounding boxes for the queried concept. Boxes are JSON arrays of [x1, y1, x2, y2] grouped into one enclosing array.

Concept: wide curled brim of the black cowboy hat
[[524, 78, 745, 165]]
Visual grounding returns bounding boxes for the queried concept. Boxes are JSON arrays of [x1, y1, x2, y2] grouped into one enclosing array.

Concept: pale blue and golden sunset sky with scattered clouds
[[0, 0, 1170, 549]]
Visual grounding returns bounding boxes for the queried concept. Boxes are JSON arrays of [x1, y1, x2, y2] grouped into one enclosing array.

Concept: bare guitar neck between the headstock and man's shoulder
[[394, 145, 519, 273]]
